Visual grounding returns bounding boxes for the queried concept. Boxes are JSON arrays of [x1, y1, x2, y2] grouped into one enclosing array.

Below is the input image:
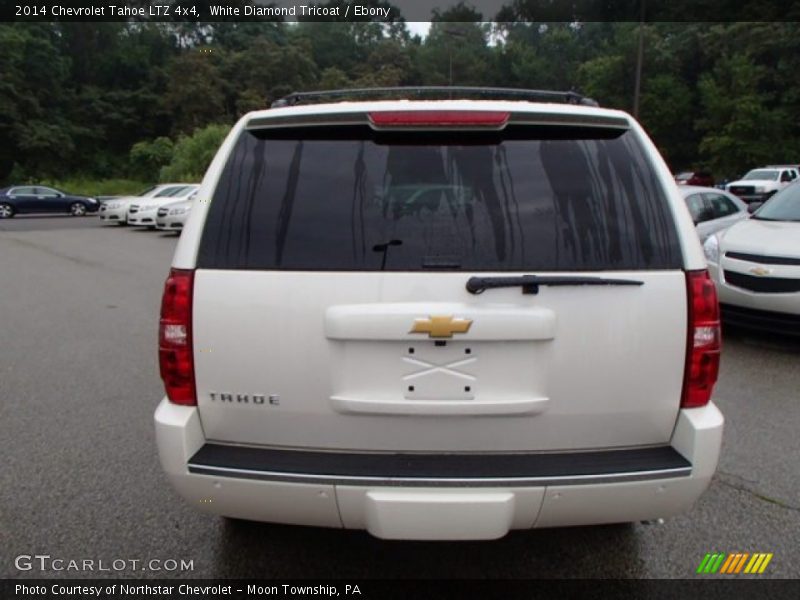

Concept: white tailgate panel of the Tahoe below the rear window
[[194, 270, 694, 451]]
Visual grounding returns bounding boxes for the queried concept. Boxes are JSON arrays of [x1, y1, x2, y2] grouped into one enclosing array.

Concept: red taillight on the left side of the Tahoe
[[158, 269, 197, 406]]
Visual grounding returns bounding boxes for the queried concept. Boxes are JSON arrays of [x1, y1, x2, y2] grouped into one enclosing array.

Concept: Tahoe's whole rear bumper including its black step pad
[[155, 400, 723, 539]]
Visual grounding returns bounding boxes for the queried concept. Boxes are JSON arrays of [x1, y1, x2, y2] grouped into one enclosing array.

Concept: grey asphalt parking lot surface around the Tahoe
[[0, 217, 800, 578]]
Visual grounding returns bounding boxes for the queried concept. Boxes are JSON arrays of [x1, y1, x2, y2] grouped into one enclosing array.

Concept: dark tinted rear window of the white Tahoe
[[198, 125, 681, 271]]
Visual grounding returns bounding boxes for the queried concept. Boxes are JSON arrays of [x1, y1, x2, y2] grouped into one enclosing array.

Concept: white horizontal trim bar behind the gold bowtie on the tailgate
[[325, 302, 556, 342]]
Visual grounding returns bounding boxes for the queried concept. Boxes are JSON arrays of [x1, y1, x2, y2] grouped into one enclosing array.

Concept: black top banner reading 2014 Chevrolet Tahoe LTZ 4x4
[[0, 0, 800, 23]]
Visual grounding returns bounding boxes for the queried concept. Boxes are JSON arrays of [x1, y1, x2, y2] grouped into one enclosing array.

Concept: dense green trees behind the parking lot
[[0, 18, 800, 184]]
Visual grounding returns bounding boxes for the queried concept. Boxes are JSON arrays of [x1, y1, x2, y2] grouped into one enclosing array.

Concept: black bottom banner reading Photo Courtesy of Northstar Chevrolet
[[0, 577, 800, 600]]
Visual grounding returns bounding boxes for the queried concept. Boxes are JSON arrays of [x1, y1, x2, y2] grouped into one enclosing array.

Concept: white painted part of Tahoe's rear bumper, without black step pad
[[155, 400, 723, 539]]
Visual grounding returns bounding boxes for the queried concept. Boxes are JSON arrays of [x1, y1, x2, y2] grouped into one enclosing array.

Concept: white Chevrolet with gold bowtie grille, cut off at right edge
[[703, 183, 800, 335]]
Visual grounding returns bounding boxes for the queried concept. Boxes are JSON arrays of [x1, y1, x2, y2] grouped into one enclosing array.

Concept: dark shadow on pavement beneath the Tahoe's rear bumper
[[211, 519, 644, 579]]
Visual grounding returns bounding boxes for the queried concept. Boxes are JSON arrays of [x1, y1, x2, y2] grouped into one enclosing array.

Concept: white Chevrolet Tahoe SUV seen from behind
[[155, 89, 723, 539]]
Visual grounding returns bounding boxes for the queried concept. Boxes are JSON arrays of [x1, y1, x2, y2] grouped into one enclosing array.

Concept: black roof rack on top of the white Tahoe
[[271, 85, 599, 108]]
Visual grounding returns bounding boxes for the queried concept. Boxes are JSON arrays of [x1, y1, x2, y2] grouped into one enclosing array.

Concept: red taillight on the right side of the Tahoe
[[681, 270, 721, 408]]
